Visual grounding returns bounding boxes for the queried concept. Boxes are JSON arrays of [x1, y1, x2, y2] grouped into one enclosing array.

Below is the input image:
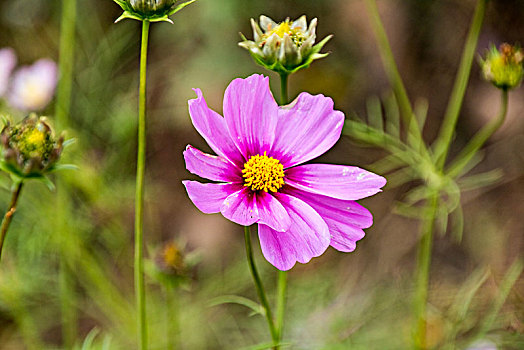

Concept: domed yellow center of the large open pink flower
[[242, 152, 284, 192]]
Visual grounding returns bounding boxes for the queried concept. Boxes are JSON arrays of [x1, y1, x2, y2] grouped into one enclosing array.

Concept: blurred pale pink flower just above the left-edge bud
[[7, 58, 58, 112]]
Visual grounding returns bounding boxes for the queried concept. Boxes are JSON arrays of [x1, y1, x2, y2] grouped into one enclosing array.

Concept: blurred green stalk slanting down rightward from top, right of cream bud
[[366, 0, 427, 153]]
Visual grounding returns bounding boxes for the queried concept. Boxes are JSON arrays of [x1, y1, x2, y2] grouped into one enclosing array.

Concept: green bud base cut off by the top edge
[[114, 0, 195, 23]]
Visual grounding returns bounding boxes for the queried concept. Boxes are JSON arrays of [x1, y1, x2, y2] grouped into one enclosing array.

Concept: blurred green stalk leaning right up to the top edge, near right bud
[[434, 0, 488, 169]]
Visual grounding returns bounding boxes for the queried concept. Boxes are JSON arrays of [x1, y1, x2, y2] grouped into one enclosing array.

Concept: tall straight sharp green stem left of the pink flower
[[135, 21, 149, 350]]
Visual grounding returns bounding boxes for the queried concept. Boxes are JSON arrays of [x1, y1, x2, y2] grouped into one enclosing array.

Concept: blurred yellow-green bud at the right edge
[[480, 43, 524, 90]]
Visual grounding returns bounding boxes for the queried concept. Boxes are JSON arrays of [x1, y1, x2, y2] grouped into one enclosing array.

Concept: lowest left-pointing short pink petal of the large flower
[[182, 180, 243, 214]]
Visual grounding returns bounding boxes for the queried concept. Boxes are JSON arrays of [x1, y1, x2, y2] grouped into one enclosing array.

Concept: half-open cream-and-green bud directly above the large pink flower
[[238, 15, 332, 74]]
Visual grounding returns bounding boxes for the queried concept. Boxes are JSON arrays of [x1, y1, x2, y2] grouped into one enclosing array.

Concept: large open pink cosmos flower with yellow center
[[183, 75, 386, 270]]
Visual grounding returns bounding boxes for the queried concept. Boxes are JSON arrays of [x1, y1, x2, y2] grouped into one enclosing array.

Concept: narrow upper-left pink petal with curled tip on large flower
[[188, 89, 245, 165]]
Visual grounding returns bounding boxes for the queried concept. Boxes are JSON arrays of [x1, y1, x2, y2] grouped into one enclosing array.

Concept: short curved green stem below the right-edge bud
[[447, 89, 508, 178]]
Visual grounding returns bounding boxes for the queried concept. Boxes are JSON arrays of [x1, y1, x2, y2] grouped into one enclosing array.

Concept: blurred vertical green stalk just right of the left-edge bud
[[55, 0, 78, 349]]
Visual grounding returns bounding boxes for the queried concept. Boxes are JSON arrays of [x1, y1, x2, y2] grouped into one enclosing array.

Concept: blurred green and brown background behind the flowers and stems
[[0, 0, 524, 350]]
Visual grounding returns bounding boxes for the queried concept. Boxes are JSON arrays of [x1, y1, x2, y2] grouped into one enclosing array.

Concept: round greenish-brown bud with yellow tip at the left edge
[[0, 114, 64, 178]]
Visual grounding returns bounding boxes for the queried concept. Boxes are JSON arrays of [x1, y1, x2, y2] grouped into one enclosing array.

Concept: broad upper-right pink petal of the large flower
[[272, 92, 344, 168]]
